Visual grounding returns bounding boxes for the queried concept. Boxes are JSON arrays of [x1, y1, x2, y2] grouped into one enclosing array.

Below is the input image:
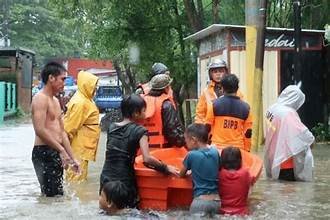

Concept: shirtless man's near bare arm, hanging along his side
[[32, 95, 65, 153]]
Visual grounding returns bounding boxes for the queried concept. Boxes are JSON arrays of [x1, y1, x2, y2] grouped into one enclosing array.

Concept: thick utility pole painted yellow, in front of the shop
[[245, 0, 267, 150]]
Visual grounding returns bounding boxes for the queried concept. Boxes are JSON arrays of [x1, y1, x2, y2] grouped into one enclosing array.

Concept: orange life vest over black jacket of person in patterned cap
[[141, 94, 171, 148]]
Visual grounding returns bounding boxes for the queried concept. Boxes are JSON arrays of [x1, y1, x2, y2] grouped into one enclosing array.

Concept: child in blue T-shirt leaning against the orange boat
[[179, 123, 220, 216]]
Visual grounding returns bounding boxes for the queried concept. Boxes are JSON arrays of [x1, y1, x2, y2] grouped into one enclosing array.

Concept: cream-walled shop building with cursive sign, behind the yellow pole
[[185, 24, 329, 128]]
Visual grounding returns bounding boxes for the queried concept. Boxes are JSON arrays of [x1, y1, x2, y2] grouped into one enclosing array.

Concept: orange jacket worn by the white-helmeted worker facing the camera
[[195, 81, 243, 124]]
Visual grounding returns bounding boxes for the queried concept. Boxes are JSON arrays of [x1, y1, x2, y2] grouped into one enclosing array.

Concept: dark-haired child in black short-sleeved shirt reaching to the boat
[[99, 94, 177, 213]]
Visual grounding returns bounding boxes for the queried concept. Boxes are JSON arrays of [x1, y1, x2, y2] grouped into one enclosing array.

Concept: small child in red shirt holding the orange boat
[[219, 147, 255, 215]]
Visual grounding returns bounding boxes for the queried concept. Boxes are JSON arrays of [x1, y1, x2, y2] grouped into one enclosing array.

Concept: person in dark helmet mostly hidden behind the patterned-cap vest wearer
[[135, 63, 176, 108]]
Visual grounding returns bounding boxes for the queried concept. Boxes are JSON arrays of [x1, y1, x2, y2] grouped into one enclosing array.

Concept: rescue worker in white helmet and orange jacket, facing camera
[[195, 59, 243, 123]]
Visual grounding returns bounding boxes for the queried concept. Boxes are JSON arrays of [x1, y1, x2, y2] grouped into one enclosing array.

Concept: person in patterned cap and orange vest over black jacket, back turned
[[141, 74, 185, 148]]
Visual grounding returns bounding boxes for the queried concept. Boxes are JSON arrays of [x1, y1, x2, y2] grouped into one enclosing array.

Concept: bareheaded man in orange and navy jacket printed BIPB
[[206, 74, 252, 151]]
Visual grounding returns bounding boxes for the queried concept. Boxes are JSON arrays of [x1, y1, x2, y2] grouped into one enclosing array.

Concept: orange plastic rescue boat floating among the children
[[135, 147, 263, 211]]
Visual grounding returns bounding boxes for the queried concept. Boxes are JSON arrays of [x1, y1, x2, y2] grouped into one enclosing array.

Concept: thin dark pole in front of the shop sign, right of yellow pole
[[293, 0, 302, 85]]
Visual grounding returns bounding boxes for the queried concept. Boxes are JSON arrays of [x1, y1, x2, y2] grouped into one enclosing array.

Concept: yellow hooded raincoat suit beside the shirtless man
[[64, 71, 100, 181]]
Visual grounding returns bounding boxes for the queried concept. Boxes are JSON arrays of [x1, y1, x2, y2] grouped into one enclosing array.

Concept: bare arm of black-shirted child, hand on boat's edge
[[139, 135, 178, 175]]
